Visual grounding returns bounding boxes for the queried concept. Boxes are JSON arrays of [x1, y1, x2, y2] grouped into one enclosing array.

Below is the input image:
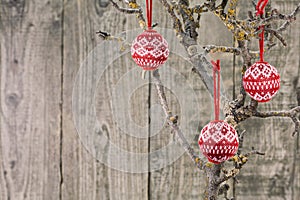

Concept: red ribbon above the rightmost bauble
[[256, 0, 268, 62]]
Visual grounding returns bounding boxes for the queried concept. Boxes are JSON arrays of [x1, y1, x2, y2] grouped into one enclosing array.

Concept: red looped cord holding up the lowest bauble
[[211, 60, 221, 121]]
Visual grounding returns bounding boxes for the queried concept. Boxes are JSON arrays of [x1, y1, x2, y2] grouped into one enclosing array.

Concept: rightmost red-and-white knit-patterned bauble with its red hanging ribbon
[[243, 0, 280, 102]]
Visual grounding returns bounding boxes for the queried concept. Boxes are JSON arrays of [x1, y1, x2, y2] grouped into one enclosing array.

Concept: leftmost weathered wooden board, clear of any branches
[[0, 0, 62, 199]]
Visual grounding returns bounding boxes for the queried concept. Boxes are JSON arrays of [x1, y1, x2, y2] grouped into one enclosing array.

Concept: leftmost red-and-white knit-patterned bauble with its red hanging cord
[[131, 0, 169, 70]]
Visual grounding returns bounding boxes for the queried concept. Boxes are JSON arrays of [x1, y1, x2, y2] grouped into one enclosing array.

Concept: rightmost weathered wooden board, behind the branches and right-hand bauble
[[236, 1, 300, 199]]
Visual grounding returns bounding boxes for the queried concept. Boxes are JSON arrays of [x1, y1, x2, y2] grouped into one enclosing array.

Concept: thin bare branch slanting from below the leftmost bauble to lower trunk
[[153, 70, 204, 170]]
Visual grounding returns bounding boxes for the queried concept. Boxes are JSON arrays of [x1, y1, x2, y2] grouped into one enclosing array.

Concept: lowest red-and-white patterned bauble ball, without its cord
[[198, 120, 239, 164]]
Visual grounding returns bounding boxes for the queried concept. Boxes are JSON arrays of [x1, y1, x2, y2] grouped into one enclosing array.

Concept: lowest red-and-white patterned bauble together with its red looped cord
[[198, 60, 239, 164]]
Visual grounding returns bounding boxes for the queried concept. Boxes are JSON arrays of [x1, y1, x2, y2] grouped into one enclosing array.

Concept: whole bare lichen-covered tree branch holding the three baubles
[[98, 0, 300, 199]]
